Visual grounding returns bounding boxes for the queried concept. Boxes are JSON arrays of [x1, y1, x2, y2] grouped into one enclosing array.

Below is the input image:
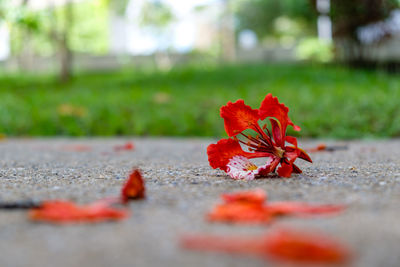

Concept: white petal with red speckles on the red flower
[[226, 156, 272, 181]]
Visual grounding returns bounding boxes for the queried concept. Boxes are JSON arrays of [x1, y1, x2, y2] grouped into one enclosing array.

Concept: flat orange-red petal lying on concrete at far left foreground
[[29, 200, 129, 223]]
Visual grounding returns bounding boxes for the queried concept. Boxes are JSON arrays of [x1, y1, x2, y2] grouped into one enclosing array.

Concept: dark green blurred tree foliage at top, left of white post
[[235, 0, 317, 39]]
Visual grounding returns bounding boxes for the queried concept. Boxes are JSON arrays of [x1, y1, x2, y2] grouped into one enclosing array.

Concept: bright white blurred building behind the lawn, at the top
[[110, 0, 220, 55]]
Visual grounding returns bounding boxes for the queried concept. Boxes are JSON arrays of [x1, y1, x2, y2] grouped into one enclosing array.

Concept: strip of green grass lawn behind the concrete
[[0, 65, 400, 138]]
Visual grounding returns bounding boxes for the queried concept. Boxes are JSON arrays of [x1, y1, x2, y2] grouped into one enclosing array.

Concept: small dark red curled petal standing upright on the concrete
[[121, 169, 145, 202]]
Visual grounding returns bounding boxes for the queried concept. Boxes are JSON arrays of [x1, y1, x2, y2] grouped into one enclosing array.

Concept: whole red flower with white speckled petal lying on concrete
[[207, 94, 312, 180]]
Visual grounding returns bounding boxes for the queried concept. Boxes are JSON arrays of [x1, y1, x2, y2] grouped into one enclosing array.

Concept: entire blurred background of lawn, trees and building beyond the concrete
[[0, 0, 400, 138]]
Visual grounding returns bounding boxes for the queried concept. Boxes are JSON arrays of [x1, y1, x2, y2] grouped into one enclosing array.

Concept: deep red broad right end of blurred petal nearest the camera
[[266, 230, 350, 263]]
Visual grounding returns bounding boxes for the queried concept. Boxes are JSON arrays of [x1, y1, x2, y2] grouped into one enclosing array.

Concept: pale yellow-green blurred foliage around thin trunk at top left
[[0, 0, 109, 56]]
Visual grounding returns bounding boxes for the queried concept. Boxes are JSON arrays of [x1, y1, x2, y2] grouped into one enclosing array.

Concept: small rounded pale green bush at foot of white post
[[296, 37, 334, 63]]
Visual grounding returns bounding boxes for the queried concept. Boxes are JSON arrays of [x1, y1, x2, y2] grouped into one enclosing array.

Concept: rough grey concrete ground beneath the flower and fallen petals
[[0, 139, 400, 267]]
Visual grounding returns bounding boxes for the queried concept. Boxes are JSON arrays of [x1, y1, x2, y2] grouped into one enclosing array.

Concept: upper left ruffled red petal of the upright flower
[[221, 99, 259, 136]]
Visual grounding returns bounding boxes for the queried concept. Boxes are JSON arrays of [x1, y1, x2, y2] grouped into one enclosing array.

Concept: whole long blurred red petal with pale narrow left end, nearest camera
[[181, 229, 351, 266]]
